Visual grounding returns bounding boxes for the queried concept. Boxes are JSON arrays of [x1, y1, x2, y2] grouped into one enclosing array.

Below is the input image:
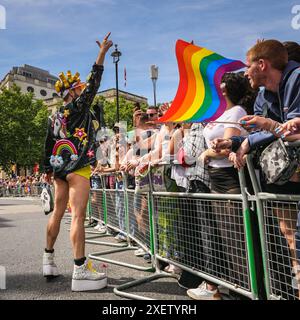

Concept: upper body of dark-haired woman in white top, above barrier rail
[[200, 73, 256, 193]]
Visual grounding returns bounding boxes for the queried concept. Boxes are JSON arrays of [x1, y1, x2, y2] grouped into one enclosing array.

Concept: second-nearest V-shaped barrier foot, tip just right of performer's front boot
[[89, 246, 155, 272]]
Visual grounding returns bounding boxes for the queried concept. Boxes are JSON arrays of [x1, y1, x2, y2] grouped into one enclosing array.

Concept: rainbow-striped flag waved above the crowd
[[158, 40, 245, 122]]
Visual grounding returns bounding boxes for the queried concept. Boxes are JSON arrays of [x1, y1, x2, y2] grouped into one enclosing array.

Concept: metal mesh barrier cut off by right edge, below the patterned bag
[[247, 148, 300, 300]]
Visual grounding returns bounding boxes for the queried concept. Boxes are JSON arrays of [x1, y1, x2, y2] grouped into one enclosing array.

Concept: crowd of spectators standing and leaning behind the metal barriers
[[88, 40, 300, 300]]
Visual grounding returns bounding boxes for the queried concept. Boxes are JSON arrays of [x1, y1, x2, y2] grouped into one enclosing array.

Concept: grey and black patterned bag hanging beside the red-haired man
[[259, 139, 298, 185]]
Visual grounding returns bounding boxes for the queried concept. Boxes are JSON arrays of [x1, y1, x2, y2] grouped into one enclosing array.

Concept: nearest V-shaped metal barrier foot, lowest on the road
[[114, 273, 177, 300]]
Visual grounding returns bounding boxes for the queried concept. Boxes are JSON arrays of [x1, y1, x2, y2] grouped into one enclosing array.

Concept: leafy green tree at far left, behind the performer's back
[[0, 85, 48, 173]]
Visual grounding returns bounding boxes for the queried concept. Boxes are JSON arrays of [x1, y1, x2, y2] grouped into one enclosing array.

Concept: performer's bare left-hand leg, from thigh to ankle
[[47, 179, 69, 250]]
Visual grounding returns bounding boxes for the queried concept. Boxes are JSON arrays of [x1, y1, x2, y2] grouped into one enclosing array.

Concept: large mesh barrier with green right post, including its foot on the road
[[114, 164, 259, 300]]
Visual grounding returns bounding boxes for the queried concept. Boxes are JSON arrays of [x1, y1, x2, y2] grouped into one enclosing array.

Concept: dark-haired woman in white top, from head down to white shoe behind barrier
[[187, 72, 256, 300]]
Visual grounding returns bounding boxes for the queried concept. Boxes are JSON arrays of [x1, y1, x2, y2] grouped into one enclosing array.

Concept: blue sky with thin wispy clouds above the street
[[0, 0, 300, 104]]
